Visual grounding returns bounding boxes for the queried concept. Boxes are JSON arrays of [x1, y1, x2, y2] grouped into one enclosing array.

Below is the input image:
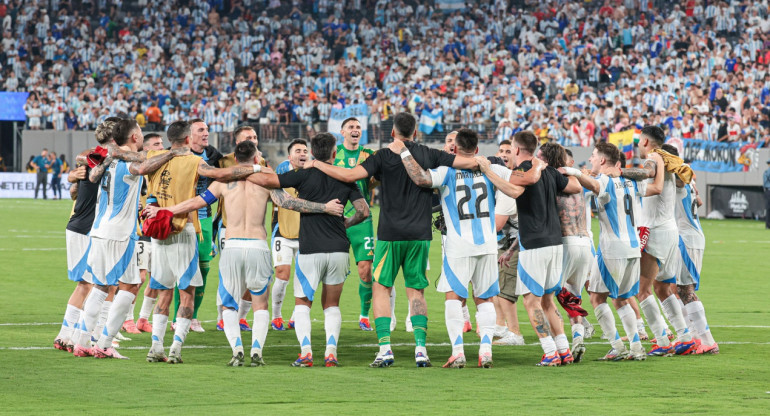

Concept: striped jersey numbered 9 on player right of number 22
[[596, 174, 641, 259]]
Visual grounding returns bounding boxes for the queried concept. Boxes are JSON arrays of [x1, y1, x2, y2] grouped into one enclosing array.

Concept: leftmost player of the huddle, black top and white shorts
[[53, 150, 97, 352]]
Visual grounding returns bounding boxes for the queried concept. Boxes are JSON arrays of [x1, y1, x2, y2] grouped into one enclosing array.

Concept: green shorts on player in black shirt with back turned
[[373, 240, 430, 289]]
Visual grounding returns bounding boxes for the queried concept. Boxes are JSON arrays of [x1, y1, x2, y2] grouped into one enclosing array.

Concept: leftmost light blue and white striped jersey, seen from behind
[[91, 160, 142, 241]]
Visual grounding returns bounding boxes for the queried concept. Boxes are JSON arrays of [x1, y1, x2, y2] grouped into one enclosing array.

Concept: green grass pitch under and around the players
[[0, 200, 770, 414]]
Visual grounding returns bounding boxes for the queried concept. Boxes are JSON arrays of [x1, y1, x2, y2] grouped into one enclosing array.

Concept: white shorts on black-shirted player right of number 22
[[516, 244, 564, 297]]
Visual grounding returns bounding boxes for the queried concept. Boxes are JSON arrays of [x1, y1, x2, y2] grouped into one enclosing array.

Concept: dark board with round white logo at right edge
[[711, 186, 767, 219]]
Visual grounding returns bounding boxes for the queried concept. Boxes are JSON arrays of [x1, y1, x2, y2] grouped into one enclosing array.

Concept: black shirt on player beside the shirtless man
[[278, 168, 363, 254]]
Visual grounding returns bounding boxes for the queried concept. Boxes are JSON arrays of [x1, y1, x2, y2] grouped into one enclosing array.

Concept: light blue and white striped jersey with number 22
[[429, 165, 511, 257]]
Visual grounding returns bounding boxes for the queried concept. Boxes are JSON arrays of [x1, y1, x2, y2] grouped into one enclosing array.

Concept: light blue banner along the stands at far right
[[680, 139, 759, 173]]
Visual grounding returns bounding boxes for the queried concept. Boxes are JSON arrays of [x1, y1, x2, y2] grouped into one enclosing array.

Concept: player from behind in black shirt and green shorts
[[305, 113, 477, 367]]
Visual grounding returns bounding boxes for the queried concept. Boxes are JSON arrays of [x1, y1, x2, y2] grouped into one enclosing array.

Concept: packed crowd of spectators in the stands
[[0, 0, 770, 146]]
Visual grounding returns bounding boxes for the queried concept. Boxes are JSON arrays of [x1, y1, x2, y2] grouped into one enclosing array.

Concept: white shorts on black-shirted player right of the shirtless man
[[294, 252, 350, 301]]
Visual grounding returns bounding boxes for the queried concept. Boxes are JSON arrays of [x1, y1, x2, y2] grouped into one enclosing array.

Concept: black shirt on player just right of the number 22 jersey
[[516, 161, 569, 251]]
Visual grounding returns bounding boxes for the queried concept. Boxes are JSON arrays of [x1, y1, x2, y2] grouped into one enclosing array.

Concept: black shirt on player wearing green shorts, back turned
[[361, 141, 455, 241]]
